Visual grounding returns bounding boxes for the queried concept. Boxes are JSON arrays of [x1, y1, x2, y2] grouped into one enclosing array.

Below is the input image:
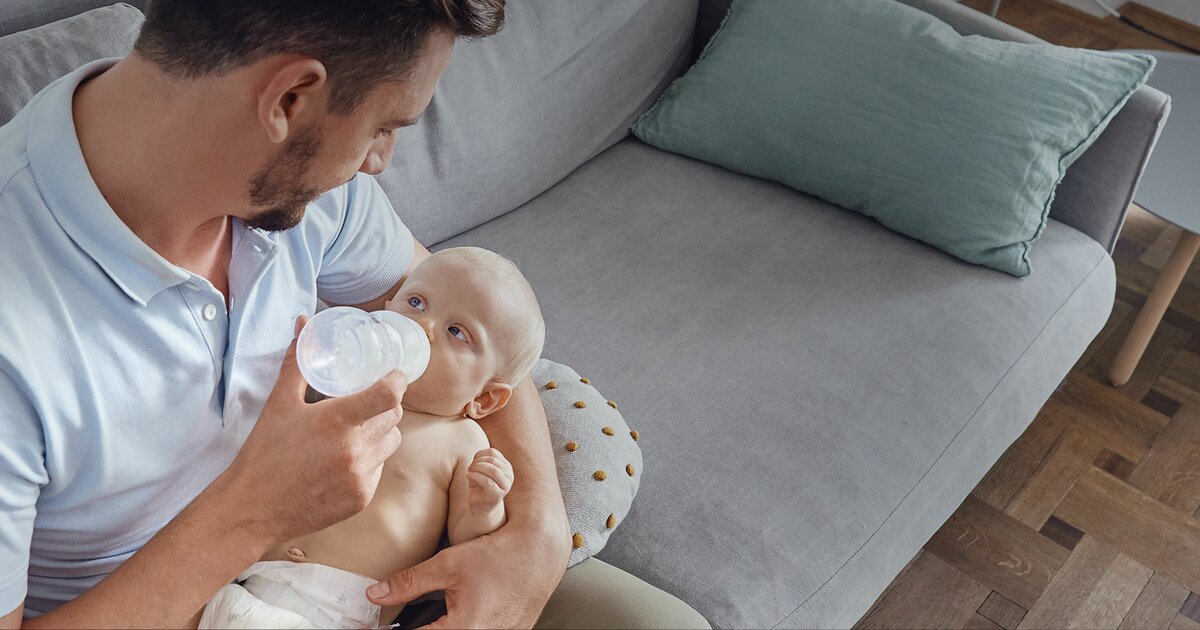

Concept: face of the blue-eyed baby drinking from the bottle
[[386, 254, 523, 416]]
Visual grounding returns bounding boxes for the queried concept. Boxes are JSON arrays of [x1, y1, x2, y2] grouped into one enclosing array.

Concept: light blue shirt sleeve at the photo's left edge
[[0, 370, 49, 616]]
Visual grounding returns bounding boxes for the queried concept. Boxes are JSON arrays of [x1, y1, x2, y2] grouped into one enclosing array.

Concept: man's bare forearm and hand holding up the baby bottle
[[6, 323, 406, 628]]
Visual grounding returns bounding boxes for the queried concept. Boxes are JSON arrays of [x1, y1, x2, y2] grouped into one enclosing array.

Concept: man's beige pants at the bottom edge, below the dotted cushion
[[396, 558, 710, 630]]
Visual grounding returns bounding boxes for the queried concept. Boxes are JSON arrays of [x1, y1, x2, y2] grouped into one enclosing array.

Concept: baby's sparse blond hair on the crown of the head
[[433, 247, 546, 385]]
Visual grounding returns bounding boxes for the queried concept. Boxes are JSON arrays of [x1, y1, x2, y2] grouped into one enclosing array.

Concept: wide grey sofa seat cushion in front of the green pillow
[[436, 139, 1115, 628]]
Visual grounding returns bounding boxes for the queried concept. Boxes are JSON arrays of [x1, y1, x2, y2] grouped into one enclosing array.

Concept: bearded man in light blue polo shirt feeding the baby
[[0, 0, 704, 628]]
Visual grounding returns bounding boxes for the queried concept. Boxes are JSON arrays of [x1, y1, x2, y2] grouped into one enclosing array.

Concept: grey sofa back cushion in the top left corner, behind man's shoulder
[[0, 4, 142, 125]]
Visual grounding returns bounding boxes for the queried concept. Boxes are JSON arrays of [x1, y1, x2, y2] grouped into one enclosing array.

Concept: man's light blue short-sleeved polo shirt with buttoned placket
[[0, 60, 413, 617]]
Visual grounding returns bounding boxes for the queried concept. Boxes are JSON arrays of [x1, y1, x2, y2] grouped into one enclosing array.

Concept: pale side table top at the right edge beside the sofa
[[1126, 50, 1200, 234]]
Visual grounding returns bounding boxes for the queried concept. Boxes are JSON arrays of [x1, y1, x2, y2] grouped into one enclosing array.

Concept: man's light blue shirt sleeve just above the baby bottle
[[317, 173, 413, 304]]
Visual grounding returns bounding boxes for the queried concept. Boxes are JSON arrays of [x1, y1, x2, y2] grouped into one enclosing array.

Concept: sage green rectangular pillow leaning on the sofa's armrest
[[632, 0, 1154, 277]]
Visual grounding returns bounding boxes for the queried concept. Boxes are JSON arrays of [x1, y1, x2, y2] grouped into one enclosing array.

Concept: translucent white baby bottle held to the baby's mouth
[[296, 306, 430, 396]]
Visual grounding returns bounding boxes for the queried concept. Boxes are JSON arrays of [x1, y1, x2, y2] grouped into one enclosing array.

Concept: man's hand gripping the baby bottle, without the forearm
[[222, 318, 407, 542]]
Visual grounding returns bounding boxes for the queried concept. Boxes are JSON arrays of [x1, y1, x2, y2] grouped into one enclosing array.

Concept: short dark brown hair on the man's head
[[133, 0, 504, 115]]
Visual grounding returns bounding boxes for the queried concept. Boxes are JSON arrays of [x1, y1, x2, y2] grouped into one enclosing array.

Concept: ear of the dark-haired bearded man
[[258, 59, 329, 144]]
